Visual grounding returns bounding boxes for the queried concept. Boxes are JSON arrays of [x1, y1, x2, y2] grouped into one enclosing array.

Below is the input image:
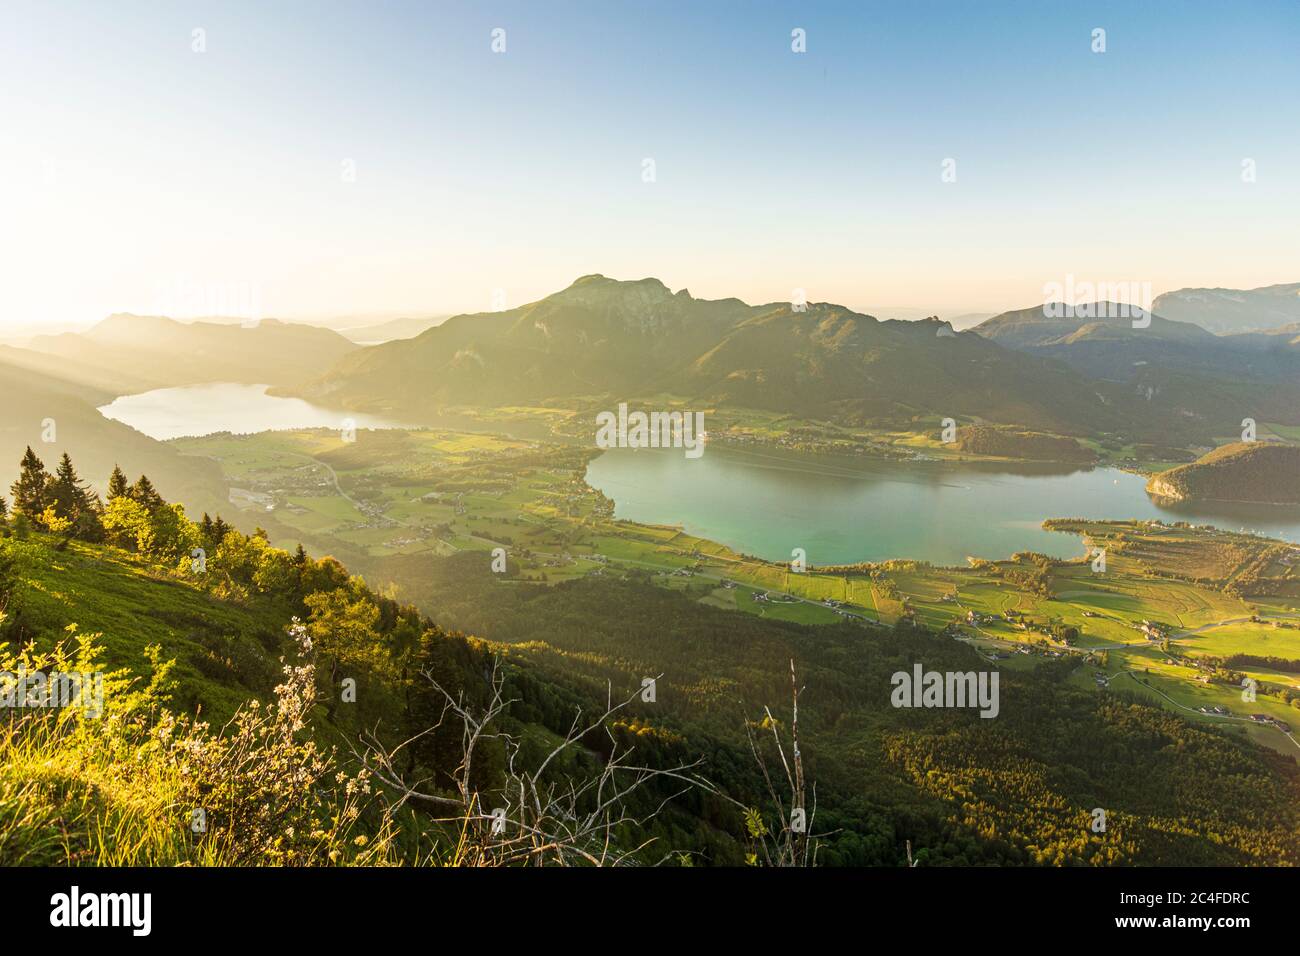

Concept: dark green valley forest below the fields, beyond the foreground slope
[[366, 554, 1300, 864]]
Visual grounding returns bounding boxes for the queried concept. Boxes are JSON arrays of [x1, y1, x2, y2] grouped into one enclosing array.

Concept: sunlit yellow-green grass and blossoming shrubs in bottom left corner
[[0, 622, 393, 866]]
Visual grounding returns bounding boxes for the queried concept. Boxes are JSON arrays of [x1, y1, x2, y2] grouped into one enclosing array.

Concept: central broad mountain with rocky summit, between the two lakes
[[283, 276, 1122, 432]]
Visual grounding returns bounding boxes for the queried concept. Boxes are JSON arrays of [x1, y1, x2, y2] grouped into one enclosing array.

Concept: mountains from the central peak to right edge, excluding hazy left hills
[[282, 276, 1300, 444]]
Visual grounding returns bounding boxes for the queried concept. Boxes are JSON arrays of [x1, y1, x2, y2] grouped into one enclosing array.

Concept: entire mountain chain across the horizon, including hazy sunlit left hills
[[10, 274, 1300, 457]]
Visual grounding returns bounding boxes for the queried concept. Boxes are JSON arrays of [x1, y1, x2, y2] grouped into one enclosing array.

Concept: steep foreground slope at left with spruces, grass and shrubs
[[0, 455, 758, 865]]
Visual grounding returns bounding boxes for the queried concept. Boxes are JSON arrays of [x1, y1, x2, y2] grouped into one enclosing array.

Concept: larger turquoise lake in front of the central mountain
[[586, 445, 1300, 564]]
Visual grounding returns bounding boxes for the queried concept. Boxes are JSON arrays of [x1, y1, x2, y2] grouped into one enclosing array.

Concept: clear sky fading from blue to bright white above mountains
[[0, 0, 1300, 328]]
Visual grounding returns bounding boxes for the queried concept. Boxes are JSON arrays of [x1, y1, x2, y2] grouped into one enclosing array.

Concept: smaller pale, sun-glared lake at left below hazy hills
[[99, 382, 402, 441]]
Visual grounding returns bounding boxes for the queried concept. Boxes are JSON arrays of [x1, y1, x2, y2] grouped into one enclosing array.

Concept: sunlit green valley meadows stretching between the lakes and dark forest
[[176, 429, 1300, 756]]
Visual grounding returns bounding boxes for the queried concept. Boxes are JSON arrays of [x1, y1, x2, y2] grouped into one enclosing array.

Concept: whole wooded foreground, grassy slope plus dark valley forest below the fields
[[0, 455, 1300, 866]]
